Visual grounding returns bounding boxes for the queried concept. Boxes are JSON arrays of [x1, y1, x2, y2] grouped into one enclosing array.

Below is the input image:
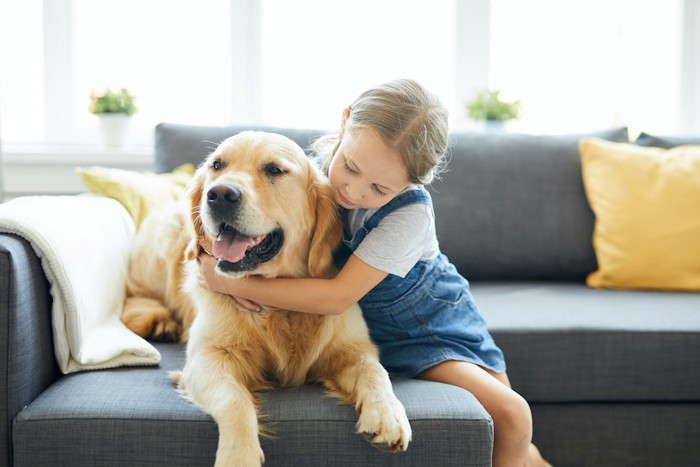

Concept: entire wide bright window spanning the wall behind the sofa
[[0, 0, 700, 149]]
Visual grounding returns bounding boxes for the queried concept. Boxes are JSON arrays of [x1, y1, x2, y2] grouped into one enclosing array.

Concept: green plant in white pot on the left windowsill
[[89, 88, 138, 148]]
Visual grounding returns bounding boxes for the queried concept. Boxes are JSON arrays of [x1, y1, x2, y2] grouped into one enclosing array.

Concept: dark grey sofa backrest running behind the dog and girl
[[154, 123, 628, 281]]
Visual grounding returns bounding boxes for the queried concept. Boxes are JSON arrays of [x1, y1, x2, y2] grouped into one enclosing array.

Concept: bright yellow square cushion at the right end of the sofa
[[580, 139, 700, 291]]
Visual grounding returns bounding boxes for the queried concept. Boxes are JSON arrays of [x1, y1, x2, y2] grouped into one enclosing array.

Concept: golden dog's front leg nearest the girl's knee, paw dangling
[[326, 344, 411, 452]]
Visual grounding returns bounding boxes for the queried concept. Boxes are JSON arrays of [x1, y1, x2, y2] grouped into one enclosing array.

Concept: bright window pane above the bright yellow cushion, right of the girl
[[490, 0, 683, 134]]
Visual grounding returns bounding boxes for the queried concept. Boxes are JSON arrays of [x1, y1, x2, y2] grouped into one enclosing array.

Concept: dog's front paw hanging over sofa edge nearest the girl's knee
[[356, 399, 411, 452]]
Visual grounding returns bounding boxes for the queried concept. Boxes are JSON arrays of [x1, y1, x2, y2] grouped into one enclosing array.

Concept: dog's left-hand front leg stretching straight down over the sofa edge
[[180, 357, 265, 467]]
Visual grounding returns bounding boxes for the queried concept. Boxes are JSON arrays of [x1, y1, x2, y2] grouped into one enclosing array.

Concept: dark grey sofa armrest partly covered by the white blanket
[[0, 234, 60, 465]]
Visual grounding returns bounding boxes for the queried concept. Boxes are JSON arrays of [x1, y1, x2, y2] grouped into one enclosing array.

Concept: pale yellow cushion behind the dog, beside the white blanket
[[75, 164, 194, 229]]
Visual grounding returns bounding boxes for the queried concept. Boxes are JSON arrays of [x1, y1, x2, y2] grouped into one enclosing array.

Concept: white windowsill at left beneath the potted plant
[[2, 143, 153, 167]]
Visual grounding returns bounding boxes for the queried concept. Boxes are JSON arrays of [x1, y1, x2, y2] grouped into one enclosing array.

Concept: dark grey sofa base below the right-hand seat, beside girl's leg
[[530, 401, 700, 467]]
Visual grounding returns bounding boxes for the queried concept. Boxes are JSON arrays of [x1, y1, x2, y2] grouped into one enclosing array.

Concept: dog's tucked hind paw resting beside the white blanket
[[121, 297, 182, 341]]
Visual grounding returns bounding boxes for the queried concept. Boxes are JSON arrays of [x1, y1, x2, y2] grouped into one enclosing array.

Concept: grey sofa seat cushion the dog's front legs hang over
[[13, 344, 493, 467]]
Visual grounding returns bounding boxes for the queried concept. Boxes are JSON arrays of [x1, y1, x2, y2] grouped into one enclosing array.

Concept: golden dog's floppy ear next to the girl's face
[[309, 173, 342, 277]]
